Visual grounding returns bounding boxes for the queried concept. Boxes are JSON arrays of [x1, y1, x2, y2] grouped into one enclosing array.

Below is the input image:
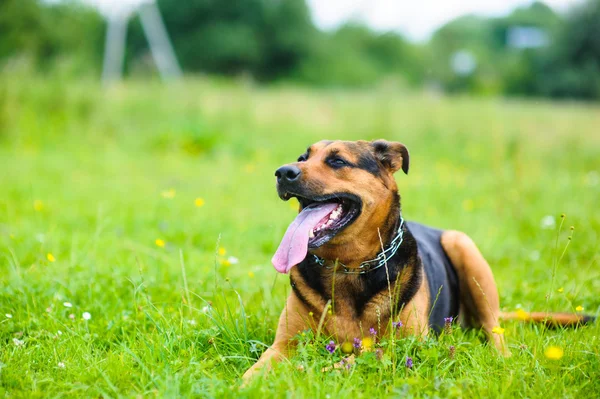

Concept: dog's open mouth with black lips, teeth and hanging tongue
[[272, 193, 362, 273]]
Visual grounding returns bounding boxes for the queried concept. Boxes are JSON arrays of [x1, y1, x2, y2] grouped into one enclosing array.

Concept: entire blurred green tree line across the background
[[0, 0, 600, 100]]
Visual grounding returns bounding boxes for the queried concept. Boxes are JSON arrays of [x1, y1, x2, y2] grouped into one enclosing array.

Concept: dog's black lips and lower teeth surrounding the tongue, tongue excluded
[[281, 193, 362, 249]]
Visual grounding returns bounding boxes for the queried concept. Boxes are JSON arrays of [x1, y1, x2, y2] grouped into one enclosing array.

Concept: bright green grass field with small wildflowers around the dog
[[0, 76, 600, 399]]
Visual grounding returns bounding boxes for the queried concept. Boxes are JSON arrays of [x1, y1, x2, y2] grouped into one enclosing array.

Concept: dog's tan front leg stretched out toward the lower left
[[242, 292, 310, 381]]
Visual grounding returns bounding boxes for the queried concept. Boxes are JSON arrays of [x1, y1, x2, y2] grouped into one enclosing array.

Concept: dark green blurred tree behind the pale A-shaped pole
[[129, 0, 316, 80]]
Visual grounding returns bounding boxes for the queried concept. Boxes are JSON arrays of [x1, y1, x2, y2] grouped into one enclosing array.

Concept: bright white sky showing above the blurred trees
[[86, 0, 581, 41]]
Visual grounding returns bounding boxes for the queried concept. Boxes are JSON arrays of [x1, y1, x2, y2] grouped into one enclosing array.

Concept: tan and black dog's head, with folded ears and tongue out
[[273, 140, 409, 272]]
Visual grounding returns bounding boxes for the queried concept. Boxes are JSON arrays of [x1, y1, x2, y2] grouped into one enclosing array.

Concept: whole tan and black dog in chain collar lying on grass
[[243, 140, 590, 380]]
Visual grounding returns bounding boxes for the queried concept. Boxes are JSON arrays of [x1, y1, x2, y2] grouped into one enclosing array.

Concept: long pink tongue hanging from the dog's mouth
[[271, 203, 338, 273]]
